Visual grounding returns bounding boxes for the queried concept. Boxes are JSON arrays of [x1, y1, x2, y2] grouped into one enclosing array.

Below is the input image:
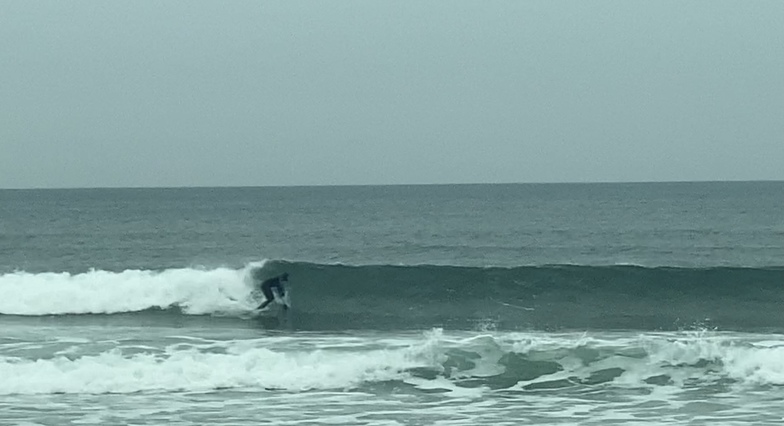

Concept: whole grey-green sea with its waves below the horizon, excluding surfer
[[0, 182, 784, 425]]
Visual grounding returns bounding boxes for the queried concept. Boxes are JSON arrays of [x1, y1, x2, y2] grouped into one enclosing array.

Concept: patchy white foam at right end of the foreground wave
[[461, 331, 784, 387]]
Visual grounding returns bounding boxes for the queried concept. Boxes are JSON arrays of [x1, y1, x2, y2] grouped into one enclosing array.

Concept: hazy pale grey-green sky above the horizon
[[0, 0, 784, 188]]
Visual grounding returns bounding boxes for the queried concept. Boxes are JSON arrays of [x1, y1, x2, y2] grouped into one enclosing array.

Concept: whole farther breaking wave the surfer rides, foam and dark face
[[0, 261, 784, 331]]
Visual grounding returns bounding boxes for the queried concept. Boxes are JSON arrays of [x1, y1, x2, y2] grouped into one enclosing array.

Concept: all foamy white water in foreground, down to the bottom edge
[[0, 327, 784, 424]]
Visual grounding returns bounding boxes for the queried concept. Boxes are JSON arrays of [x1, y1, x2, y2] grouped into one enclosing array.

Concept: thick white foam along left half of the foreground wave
[[0, 347, 422, 395]]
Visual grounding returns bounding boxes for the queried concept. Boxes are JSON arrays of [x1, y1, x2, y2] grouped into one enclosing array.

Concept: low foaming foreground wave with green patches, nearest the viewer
[[0, 329, 784, 398]]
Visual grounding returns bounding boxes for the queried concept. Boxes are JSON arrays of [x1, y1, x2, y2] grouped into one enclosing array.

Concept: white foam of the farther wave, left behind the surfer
[[0, 265, 262, 315]]
